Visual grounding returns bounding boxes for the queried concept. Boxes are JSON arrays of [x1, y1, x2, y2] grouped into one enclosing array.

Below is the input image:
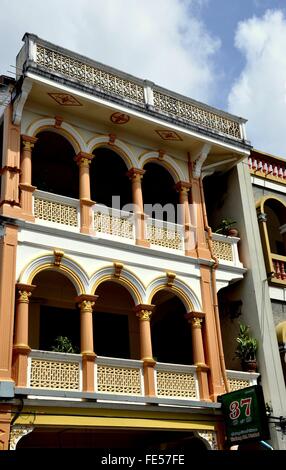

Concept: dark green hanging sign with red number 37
[[218, 385, 269, 445]]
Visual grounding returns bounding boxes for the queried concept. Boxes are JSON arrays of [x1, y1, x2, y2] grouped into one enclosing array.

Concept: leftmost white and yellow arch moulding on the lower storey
[[18, 253, 89, 295]]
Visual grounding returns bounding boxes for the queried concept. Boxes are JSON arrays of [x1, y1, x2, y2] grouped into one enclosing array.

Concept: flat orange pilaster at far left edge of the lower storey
[[0, 225, 18, 381]]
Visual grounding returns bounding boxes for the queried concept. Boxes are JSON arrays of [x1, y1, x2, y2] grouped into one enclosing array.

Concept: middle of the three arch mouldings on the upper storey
[[86, 135, 138, 170]]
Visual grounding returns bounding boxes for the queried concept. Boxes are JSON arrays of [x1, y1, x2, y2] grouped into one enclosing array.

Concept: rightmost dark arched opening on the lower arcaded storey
[[151, 289, 193, 365]]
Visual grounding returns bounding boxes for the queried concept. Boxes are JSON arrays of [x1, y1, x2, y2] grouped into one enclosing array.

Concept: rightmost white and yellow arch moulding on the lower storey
[[146, 276, 202, 312]]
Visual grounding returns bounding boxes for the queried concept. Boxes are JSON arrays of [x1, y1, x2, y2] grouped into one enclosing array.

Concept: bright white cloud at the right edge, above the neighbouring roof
[[228, 10, 286, 157]]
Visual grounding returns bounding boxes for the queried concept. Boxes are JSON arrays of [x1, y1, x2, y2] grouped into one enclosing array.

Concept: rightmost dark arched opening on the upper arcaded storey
[[142, 162, 179, 223]]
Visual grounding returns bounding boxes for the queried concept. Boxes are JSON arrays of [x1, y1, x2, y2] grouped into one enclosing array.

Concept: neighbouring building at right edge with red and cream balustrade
[[248, 150, 286, 382]]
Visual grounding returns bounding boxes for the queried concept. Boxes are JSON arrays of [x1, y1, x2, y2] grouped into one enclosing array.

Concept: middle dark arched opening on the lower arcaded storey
[[93, 281, 136, 359]]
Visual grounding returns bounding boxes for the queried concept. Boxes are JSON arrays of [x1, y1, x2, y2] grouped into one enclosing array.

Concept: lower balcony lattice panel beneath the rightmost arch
[[157, 371, 197, 398]]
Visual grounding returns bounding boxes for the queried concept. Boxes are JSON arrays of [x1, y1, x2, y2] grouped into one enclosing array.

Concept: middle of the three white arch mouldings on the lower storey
[[90, 265, 145, 305]]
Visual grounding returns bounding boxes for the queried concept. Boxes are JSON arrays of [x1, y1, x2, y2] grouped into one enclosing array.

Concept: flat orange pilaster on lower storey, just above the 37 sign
[[200, 265, 225, 400]]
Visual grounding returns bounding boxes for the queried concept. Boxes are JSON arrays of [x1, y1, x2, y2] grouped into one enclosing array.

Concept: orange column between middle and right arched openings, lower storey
[[135, 304, 156, 396]]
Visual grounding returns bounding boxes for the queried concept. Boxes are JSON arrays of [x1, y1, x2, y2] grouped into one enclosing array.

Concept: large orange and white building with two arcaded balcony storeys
[[0, 34, 280, 450]]
